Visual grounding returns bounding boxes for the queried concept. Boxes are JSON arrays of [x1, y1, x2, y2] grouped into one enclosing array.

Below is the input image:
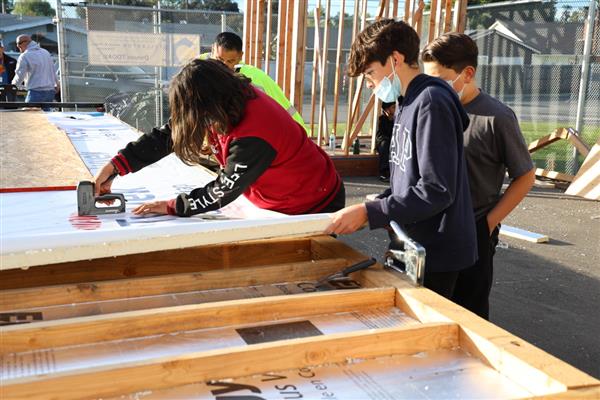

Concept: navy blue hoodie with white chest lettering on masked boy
[[366, 74, 477, 273]]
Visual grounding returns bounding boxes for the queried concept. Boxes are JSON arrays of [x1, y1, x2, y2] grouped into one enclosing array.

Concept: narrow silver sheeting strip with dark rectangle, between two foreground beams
[[0, 308, 419, 383]]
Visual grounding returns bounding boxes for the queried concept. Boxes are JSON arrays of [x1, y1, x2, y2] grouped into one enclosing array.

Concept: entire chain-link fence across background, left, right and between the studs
[[48, 0, 600, 173]]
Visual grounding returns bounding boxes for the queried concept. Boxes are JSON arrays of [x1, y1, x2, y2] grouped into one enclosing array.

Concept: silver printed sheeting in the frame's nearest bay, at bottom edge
[[114, 350, 533, 400]]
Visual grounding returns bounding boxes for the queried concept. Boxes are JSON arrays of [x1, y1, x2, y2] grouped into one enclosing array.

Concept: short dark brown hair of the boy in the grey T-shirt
[[421, 32, 479, 73]]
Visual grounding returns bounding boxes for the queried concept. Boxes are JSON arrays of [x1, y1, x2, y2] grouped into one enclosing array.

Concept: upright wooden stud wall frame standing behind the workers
[[244, 0, 474, 156]]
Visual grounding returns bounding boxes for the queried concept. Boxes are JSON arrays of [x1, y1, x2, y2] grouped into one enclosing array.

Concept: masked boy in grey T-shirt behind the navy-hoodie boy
[[421, 33, 535, 319]]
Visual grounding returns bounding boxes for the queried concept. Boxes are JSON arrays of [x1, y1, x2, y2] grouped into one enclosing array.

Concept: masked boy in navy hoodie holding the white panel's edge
[[327, 19, 477, 298]]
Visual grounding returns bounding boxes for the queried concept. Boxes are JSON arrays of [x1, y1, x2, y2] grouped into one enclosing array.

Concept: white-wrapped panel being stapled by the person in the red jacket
[[0, 112, 329, 269]]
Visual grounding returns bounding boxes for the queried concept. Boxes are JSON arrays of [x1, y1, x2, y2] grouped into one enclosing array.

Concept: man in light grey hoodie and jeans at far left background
[[12, 35, 59, 111]]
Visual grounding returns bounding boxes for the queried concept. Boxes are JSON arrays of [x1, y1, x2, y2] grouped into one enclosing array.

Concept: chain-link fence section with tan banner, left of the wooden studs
[[57, 2, 243, 132]]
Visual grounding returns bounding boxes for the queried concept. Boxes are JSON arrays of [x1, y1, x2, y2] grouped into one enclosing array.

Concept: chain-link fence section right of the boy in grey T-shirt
[[467, 0, 600, 173]]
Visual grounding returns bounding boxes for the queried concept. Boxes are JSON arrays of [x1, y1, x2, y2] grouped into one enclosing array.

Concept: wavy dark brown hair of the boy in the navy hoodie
[[348, 19, 419, 76]]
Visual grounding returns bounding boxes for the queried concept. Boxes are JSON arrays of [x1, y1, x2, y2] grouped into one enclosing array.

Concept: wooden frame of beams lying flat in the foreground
[[0, 237, 600, 399]]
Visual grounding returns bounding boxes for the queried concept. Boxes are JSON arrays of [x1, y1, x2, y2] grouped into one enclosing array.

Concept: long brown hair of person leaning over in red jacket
[[169, 60, 256, 165]]
